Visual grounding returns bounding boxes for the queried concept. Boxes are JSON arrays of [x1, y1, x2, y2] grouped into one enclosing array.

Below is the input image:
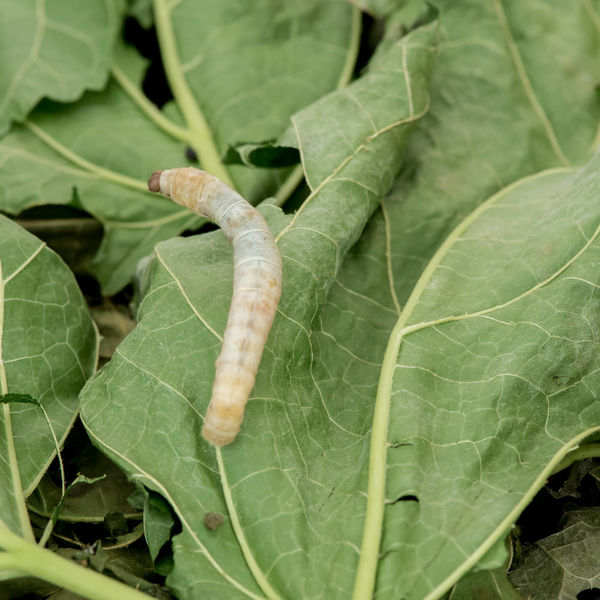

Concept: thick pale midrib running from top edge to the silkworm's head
[[154, 0, 235, 189]]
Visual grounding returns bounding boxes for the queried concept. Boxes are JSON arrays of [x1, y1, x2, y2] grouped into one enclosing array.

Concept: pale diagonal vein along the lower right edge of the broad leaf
[[423, 426, 600, 600]]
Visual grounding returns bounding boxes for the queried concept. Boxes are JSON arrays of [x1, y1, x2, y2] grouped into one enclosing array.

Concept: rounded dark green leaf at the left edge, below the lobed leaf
[[0, 216, 98, 536]]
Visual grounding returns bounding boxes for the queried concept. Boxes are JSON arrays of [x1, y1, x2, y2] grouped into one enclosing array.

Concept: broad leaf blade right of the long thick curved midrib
[[368, 149, 600, 598]]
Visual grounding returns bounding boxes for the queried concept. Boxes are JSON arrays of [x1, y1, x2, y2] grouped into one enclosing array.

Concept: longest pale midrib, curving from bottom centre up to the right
[[353, 163, 574, 600]]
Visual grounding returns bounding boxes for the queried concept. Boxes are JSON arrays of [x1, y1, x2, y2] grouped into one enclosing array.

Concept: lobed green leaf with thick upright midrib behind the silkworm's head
[[0, 0, 359, 294]]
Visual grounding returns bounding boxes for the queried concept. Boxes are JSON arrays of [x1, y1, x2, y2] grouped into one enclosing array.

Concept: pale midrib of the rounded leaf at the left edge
[[0, 259, 35, 541]]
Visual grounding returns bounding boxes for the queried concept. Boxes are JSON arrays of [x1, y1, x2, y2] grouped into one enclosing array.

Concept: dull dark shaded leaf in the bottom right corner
[[509, 508, 600, 600]]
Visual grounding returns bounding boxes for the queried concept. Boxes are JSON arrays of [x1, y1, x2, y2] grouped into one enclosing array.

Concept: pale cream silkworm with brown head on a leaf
[[148, 167, 281, 446]]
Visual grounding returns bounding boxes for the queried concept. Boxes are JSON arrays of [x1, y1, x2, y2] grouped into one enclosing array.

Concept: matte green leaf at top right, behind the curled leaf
[[378, 0, 600, 305]]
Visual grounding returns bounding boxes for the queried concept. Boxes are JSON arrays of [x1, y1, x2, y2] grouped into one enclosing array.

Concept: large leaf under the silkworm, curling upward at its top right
[[82, 19, 436, 598]]
